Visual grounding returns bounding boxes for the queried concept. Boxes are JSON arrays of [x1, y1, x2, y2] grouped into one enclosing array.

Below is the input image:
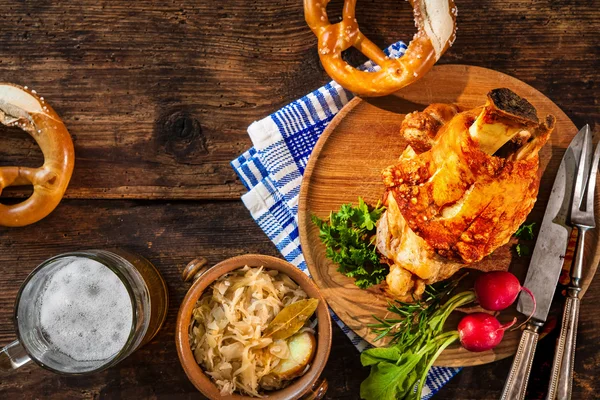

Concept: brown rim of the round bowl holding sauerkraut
[[175, 254, 332, 400]]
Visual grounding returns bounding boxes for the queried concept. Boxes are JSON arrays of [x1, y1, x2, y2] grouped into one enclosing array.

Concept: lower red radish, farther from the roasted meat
[[458, 313, 517, 352]]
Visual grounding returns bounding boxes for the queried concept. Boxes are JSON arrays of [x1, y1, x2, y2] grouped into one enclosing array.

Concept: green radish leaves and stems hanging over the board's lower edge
[[360, 291, 475, 400]]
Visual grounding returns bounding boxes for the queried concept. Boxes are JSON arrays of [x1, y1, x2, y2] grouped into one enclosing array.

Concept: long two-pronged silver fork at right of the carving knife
[[547, 125, 600, 400]]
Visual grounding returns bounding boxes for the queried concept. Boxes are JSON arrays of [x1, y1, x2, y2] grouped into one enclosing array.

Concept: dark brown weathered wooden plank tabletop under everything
[[0, 0, 600, 399]]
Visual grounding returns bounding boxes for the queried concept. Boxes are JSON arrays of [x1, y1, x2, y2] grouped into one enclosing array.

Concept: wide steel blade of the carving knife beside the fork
[[517, 130, 585, 323]]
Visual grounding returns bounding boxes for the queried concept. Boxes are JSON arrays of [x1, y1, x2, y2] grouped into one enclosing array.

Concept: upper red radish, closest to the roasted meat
[[475, 271, 535, 314]]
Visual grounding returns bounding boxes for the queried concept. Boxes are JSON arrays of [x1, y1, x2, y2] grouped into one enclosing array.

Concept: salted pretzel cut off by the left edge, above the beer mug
[[0, 83, 75, 226]]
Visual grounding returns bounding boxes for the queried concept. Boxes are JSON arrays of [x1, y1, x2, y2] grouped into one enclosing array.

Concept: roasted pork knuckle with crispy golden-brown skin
[[378, 92, 554, 297]]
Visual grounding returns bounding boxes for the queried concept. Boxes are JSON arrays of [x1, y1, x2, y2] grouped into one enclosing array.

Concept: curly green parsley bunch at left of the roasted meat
[[312, 197, 388, 289]]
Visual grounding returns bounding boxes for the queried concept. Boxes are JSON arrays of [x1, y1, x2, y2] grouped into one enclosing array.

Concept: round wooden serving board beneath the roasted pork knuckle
[[299, 65, 600, 366]]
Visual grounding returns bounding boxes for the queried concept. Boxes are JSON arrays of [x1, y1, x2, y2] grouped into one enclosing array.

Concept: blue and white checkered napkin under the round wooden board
[[231, 42, 460, 399]]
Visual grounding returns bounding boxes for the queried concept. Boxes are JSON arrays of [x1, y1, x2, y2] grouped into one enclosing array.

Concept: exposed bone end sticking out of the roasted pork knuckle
[[469, 88, 539, 155]]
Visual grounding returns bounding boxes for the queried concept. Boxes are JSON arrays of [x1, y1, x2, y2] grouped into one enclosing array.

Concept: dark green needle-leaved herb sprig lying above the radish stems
[[369, 274, 466, 343]]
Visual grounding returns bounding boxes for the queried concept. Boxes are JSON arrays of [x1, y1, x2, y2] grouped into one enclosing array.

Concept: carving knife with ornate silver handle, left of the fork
[[501, 131, 585, 400]]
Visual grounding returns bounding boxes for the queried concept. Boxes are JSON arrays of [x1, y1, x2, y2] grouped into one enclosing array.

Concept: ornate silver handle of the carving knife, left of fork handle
[[500, 322, 540, 400]]
